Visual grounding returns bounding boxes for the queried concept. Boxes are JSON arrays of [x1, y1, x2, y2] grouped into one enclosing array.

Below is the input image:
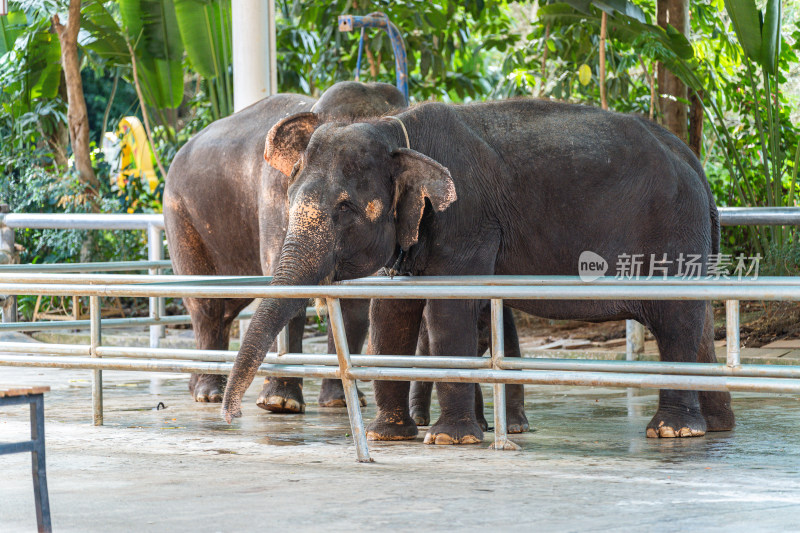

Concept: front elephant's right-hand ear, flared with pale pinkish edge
[[392, 148, 457, 250]]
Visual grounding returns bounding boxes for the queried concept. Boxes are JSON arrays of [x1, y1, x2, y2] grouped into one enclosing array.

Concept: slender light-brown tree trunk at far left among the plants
[[53, 0, 100, 191]]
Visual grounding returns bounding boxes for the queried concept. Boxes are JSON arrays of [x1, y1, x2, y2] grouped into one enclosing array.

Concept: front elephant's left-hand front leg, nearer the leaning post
[[367, 300, 425, 440]]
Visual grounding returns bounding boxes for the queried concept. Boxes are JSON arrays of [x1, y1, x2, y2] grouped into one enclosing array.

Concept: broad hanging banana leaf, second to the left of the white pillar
[[119, 0, 183, 109]]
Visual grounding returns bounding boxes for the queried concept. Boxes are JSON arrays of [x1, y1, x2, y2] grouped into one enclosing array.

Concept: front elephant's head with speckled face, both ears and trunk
[[223, 113, 456, 422]]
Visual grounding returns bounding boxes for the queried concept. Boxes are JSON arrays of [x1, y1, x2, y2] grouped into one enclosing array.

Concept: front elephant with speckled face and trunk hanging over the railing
[[222, 99, 735, 444]]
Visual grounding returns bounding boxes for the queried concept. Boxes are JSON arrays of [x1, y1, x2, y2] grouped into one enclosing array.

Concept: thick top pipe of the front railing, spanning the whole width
[[0, 282, 800, 301]]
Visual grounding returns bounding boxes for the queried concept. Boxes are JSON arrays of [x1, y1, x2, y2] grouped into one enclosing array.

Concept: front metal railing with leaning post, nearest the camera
[[0, 274, 800, 461]]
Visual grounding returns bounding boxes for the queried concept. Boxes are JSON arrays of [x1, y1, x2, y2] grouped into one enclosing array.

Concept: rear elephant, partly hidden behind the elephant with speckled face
[[164, 82, 405, 412]]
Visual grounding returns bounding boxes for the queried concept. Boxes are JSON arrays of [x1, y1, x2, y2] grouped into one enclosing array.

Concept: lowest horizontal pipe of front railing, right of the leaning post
[[348, 367, 800, 394]]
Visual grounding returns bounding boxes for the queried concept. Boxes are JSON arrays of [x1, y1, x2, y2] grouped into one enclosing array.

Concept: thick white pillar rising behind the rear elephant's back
[[231, 0, 277, 111]]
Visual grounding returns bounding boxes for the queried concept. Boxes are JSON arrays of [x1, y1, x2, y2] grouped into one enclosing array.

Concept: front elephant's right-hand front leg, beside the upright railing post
[[425, 300, 483, 444]]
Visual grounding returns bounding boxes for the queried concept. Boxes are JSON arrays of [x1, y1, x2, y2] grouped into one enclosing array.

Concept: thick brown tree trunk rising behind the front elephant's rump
[[656, 0, 689, 142]]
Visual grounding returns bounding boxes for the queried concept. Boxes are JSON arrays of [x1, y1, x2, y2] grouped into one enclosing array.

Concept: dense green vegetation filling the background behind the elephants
[[0, 0, 800, 273]]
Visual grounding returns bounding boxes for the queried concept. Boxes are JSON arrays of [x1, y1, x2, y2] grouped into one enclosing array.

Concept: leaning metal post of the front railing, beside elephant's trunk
[[327, 298, 372, 463]]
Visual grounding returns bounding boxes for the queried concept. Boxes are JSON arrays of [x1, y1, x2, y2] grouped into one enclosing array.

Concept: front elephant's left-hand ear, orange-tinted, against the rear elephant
[[264, 112, 319, 176]]
